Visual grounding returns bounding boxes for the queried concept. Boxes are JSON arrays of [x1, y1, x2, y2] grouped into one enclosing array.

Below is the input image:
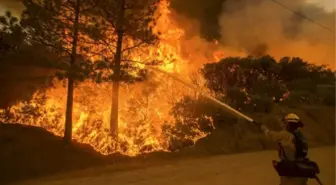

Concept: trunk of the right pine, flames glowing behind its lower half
[[110, 0, 125, 139]]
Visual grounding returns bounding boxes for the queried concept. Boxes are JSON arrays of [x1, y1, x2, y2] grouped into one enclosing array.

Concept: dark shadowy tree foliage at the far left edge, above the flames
[[0, 12, 60, 108]]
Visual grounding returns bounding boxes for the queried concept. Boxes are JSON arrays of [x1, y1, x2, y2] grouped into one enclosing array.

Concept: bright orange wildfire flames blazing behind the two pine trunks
[[0, 1, 230, 156]]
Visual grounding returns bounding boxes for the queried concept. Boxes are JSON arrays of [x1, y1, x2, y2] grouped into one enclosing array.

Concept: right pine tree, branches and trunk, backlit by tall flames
[[92, 0, 159, 138]]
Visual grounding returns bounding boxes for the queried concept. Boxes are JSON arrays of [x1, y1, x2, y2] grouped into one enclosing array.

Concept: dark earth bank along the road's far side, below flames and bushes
[[0, 106, 336, 183]]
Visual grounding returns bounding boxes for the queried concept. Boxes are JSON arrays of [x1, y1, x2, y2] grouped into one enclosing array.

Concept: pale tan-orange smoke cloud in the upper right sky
[[219, 0, 336, 67]]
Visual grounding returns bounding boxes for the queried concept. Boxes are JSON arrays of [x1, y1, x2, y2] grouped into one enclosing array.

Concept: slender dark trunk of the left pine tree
[[64, 0, 80, 144]]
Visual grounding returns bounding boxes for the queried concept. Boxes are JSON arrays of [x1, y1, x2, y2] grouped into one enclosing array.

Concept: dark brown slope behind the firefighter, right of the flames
[[182, 106, 336, 155]]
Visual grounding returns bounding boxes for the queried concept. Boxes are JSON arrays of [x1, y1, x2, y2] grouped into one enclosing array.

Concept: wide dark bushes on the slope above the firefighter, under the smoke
[[201, 56, 335, 111]]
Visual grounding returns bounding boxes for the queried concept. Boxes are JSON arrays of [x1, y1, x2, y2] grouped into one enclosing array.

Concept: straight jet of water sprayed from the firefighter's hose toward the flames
[[145, 65, 254, 123]]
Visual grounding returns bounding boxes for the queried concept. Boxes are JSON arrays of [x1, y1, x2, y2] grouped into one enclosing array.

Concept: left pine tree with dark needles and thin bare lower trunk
[[22, 0, 101, 143]]
